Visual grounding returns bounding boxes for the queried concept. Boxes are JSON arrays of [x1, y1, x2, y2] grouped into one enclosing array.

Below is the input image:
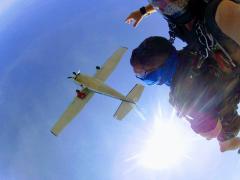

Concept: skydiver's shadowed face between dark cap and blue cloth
[[132, 55, 167, 76]]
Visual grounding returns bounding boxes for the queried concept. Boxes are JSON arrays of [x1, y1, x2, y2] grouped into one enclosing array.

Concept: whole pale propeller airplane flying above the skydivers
[[51, 47, 144, 136]]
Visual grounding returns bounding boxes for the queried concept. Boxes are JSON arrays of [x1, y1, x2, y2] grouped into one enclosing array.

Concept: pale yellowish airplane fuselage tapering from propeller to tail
[[74, 74, 135, 104]]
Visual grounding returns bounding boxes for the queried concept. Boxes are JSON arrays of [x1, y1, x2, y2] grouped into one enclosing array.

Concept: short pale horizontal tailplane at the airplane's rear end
[[114, 84, 144, 120]]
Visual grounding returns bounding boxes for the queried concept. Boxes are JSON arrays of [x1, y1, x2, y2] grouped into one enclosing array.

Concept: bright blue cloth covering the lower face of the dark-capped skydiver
[[136, 52, 179, 86]]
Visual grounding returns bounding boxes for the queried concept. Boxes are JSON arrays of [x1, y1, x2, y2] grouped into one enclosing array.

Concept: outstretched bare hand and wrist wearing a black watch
[[125, 4, 156, 27]]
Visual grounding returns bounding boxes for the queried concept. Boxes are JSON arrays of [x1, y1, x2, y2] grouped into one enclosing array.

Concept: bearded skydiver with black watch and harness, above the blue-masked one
[[126, 0, 240, 67]]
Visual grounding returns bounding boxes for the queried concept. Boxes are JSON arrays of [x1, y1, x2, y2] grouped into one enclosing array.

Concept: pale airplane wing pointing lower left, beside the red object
[[51, 88, 94, 136]]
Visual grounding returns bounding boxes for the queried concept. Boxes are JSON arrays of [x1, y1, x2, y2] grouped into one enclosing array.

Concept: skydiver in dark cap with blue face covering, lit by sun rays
[[130, 36, 240, 152]]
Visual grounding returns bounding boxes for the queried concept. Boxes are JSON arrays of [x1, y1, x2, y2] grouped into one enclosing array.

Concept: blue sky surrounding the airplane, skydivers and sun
[[0, 0, 240, 180]]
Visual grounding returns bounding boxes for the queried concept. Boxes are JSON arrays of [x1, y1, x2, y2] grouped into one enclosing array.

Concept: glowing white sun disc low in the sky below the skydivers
[[136, 107, 189, 170]]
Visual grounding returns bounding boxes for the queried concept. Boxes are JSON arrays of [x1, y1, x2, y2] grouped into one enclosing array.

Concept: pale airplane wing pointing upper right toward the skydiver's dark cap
[[95, 47, 127, 81]]
